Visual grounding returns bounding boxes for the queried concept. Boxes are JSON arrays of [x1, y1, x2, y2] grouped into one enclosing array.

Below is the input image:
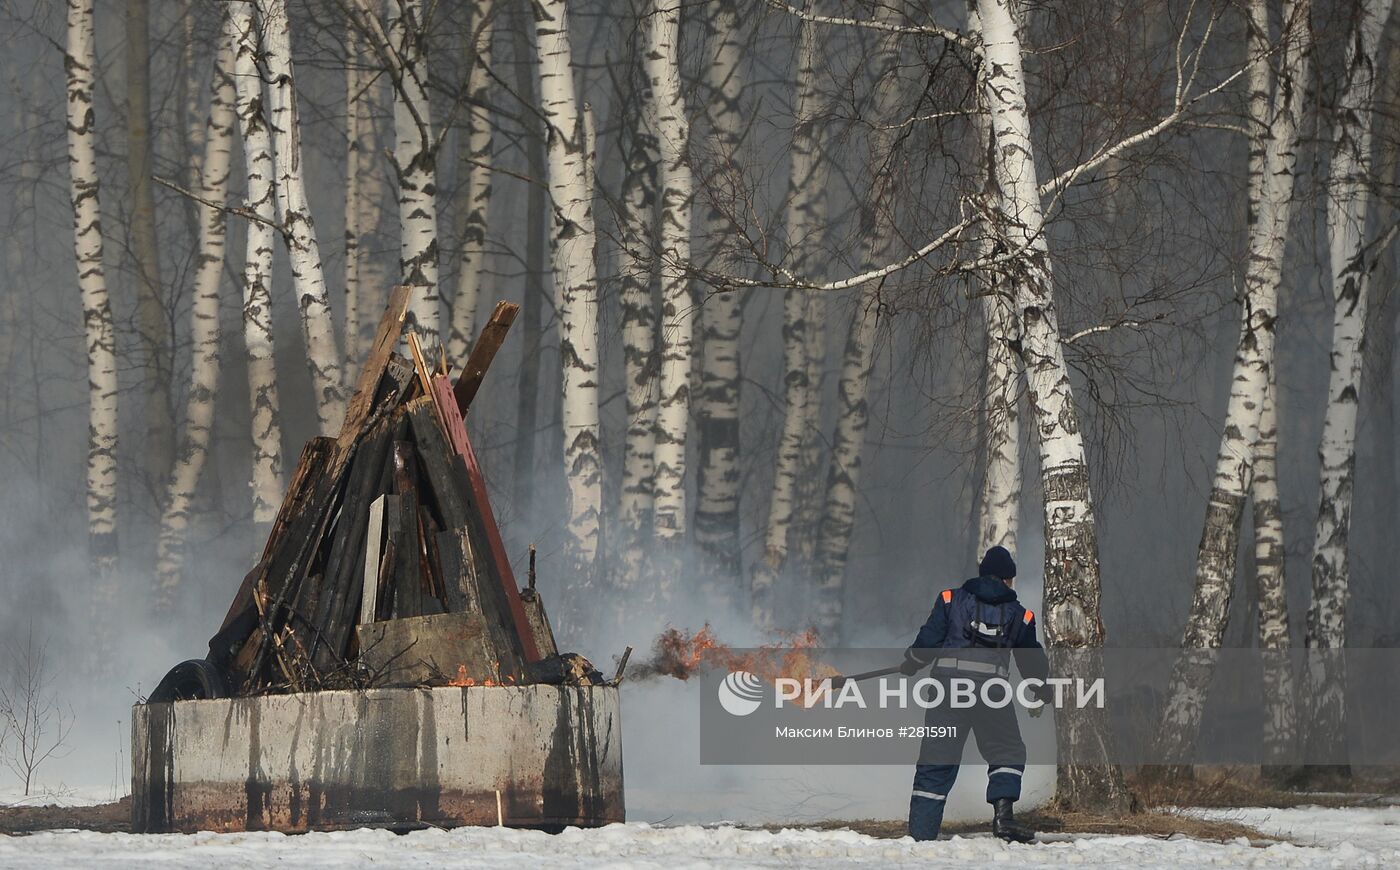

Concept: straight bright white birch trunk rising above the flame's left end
[[645, 0, 694, 557]]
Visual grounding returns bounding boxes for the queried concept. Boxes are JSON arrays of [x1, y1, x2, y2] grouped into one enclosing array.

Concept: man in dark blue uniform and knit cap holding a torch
[[900, 546, 1047, 842]]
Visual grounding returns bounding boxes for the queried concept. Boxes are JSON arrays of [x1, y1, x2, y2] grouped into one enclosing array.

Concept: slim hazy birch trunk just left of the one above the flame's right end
[[749, 21, 830, 629]]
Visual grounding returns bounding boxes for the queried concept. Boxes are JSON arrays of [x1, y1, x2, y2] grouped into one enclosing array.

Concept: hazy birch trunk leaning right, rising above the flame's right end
[[812, 3, 903, 646]]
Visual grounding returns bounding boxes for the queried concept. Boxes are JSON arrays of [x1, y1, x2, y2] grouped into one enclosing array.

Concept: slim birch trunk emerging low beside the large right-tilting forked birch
[[1249, 370, 1296, 765]]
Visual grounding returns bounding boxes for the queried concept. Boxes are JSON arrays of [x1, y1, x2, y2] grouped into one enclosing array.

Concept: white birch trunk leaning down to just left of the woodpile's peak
[[256, 0, 344, 434]]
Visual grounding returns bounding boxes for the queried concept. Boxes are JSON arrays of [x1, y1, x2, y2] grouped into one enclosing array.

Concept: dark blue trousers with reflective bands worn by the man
[[909, 680, 1026, 841]]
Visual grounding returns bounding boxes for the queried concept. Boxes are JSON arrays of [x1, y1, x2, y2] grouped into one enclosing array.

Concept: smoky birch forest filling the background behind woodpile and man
[[0, 0, 1400, 810]]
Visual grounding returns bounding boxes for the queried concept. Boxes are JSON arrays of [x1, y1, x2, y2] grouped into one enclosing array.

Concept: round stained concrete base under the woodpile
[[132, 685, 624, 834]]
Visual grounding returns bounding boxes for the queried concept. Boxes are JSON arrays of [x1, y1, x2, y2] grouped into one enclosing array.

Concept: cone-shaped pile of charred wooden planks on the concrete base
[[209, 287, 557, 695]]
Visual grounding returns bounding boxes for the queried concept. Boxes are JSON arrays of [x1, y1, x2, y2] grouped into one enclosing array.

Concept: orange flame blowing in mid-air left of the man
[[640, 622, 837, 682]]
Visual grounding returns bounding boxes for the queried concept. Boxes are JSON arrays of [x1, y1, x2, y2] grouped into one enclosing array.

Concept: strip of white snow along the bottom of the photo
[[0, 808, 1400, 870]]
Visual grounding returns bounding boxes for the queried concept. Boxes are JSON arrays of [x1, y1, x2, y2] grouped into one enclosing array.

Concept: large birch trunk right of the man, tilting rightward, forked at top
[[1158, 0, 1312, 765]]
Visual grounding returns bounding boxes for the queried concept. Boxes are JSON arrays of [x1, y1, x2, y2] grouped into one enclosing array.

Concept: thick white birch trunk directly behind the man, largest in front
[[977, 0, 1128, 813]]
